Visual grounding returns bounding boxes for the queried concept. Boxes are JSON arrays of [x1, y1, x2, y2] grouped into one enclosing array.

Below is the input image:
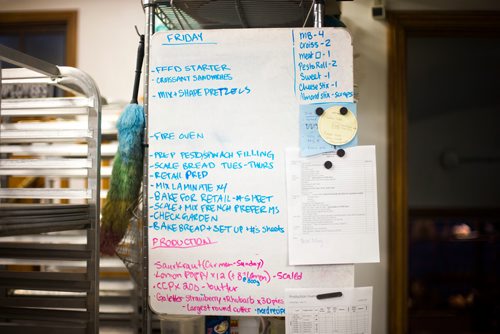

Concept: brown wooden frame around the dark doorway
[[387, 11, 500, 334]]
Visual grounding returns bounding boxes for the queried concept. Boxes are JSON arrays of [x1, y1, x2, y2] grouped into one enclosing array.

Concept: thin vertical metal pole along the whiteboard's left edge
[[141, 0, 155, 334]]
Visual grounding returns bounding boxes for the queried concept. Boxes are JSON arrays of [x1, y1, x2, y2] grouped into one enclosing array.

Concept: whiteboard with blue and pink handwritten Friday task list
[[148, 28, 354, 316]]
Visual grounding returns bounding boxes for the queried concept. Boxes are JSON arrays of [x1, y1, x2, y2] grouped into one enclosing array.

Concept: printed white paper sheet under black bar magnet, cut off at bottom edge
[[285, 287, 373, 334]]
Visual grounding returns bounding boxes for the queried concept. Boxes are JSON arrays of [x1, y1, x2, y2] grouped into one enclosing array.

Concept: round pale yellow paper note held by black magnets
[[318, 106, 358, 145]]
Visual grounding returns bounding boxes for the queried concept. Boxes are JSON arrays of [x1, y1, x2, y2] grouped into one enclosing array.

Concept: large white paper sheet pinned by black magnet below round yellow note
[[286, 146, 379, 265]]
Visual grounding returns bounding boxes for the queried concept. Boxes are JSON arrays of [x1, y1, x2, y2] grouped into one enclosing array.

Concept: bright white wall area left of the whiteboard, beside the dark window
[[0, 0, 144, 103]]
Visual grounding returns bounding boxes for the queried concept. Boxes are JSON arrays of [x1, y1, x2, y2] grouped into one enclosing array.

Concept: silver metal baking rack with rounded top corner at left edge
[[0, 45, 101, 334]]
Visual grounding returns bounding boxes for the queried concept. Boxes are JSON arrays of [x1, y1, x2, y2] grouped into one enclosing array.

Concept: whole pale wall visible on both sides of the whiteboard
[[0, 0, 500, 334]]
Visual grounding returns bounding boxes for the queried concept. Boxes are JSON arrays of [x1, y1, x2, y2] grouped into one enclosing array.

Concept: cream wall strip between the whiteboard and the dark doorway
[[342, 0, 388, 334]]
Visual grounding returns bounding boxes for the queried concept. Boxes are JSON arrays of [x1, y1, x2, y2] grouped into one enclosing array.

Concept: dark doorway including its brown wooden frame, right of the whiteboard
[[389, 12, 500, 334]]
